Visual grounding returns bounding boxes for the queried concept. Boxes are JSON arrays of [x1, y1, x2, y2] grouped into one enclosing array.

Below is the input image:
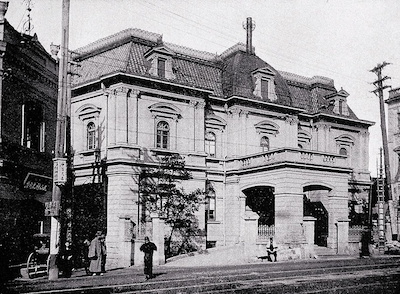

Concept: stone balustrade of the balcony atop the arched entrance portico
[[226, 148, 349, 171]]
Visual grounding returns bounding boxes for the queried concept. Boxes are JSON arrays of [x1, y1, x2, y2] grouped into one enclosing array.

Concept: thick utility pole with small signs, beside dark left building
[[49, 0, 70, 280]]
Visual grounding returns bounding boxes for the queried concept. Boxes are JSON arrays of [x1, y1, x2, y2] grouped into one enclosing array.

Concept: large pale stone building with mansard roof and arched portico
[[72, 25, 373, 267]]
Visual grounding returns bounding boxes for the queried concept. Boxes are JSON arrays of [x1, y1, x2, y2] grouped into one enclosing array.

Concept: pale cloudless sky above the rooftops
[[3, 0, 400, 176]]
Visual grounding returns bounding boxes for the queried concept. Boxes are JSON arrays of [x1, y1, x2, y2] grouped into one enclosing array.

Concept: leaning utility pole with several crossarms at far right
[[370, 62, 397, 240]]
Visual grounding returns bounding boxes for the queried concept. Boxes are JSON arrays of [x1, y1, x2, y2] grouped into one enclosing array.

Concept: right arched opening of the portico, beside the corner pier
[[303, 185, 331, 247]]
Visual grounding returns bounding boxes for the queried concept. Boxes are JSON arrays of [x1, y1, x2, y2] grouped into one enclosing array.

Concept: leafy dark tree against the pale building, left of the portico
[[139, 154, 204, 257]]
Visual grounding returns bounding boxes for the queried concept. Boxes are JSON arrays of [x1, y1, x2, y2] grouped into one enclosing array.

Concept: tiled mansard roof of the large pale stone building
[[73, 29, 357, 119]]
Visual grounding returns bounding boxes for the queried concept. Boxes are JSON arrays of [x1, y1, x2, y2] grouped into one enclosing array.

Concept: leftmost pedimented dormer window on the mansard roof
[[144, 46, 175, 80]]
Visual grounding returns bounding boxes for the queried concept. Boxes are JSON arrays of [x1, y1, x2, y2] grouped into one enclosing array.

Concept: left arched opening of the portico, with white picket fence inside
[[243, 186, 275, 239]]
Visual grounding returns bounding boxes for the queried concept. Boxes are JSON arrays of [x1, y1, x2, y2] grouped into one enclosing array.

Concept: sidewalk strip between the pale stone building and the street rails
[[0, 254, 400, 294]]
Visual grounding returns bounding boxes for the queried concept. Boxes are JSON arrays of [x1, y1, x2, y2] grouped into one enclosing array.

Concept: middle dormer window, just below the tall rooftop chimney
[[253, 67, 277, 101]]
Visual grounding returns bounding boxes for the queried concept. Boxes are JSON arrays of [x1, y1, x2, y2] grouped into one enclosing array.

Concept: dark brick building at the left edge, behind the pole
[[0, 1, 57, 264]]
